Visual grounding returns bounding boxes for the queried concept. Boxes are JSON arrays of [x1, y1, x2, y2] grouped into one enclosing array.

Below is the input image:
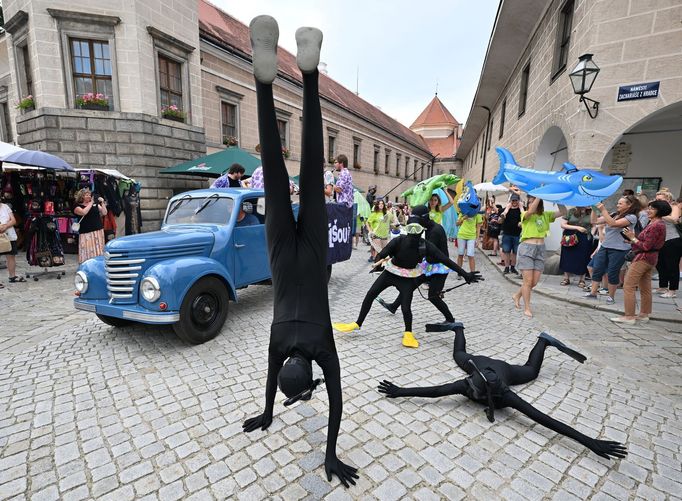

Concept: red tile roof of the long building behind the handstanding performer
[[199, 0, 429, 153]]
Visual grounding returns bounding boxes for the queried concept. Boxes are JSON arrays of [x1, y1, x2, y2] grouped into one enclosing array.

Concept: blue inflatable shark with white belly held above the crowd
[[493, 147, 623, 207]]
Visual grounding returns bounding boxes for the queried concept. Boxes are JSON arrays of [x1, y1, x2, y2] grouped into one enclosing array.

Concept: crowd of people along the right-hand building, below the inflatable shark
[[478, 186, 682, 324]]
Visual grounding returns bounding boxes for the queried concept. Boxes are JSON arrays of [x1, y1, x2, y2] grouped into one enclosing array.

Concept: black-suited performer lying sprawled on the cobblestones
[[378, 323, 627, 459]]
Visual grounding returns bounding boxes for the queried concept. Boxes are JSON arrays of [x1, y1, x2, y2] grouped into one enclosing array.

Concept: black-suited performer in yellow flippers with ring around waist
[[333, 223, 483, 348]]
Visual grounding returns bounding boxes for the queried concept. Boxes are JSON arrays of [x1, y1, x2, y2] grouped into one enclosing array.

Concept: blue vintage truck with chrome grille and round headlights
[[74, 188, 351, 344]]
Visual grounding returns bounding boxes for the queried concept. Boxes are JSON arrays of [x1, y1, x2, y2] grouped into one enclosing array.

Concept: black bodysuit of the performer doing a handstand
[[245, 71, 345, 474]]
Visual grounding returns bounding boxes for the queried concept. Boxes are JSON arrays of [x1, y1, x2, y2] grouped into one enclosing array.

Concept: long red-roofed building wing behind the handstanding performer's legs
[[199, 1, 433, 201]]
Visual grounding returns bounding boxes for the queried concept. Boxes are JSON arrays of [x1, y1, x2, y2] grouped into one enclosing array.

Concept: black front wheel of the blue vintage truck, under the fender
[[173, 277, 230, 344]]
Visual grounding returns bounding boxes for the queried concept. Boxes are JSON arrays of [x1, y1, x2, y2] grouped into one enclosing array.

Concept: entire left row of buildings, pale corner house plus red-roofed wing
[[0, 0, 433, 230]]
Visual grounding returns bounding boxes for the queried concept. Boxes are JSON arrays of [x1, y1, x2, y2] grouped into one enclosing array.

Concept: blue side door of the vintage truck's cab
[[233, 197, 270, 287]]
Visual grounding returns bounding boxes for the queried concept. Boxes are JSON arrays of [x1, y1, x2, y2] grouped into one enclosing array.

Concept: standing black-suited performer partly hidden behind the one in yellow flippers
[[377, 205, 455, 324]]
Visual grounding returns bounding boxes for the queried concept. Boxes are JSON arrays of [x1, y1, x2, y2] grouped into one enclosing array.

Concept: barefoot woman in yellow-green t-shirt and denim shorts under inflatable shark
[[512, 189, 567, 317]]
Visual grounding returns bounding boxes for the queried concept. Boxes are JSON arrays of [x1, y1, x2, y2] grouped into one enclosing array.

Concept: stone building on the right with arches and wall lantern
[[457, 0, 682, 199]]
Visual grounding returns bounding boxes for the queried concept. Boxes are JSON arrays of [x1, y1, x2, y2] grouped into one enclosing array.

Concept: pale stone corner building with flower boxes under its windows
[[0, 0, 206, 229]]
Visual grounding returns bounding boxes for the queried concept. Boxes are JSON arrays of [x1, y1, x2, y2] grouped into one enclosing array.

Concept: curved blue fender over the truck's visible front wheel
[[140, 256, 237, 311]]
